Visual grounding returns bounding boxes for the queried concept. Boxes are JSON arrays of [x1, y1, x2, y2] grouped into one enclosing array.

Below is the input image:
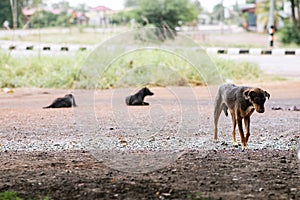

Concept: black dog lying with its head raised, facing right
[[125, 87, 154, 106]]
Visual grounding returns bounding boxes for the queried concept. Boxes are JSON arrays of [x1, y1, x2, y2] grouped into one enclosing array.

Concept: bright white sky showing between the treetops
[[46, 0, 246, 12]]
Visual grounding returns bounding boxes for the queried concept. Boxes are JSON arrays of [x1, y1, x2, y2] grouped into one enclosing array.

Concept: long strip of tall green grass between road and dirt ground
[[0, 51, 263, 89]]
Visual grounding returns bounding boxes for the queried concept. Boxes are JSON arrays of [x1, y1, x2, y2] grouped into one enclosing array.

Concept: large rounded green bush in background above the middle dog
[[136, 0, 199, 32]]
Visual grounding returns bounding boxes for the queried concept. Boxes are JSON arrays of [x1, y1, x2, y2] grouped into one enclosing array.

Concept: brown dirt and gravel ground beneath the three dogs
[[0, 81, 300, 199]]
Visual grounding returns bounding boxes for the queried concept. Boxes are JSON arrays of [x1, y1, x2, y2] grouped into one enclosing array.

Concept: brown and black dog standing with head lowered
[[214, 84, 270, 150]]
